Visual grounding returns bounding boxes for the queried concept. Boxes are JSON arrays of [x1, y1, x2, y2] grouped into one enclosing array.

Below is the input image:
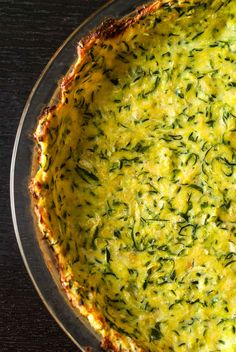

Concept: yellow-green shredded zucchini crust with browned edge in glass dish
[[30, 0, 236, 352]]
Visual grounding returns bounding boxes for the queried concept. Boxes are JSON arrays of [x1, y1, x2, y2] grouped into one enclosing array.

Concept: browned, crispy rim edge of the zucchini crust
[[29, 0, 172, 352]]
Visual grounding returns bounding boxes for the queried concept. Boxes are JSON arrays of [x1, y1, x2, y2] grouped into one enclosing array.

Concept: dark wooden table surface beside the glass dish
[[0, 0, 106, 352]]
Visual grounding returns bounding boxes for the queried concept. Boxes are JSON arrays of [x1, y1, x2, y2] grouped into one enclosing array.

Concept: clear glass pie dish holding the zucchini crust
[[10, 0, 151, 352]]
